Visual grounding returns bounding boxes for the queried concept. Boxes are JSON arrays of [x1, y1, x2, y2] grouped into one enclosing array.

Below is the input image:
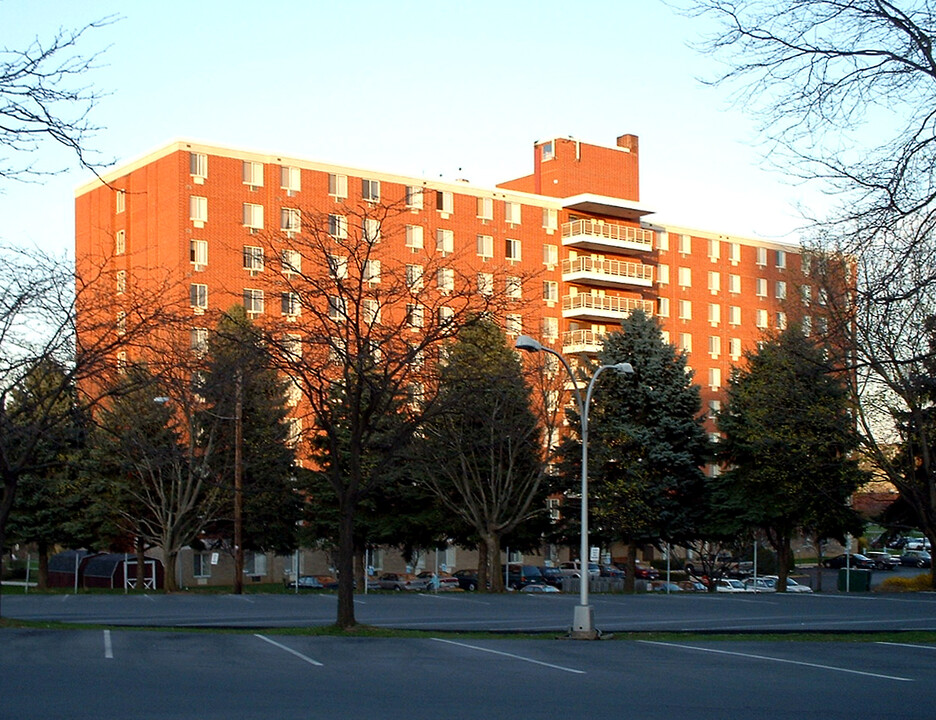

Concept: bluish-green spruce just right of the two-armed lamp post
[[563, 311, 708, 589]]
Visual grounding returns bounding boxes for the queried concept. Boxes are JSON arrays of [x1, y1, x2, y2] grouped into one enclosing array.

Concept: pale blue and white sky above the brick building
[[0, 0, 811, 252]]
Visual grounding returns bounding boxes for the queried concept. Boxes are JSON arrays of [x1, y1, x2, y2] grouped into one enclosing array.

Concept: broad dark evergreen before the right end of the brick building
[[715, 325, 867, 590]]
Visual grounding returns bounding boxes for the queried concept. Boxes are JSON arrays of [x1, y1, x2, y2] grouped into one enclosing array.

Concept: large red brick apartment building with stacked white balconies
[[75, 135, 821, 584]]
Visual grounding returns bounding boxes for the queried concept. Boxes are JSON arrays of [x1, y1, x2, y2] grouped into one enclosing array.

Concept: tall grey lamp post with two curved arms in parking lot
[[515, 335, 634, 640]]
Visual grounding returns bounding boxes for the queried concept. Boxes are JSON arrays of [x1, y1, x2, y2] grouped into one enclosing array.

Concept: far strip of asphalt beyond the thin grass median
[[3, 593, 936, 633]]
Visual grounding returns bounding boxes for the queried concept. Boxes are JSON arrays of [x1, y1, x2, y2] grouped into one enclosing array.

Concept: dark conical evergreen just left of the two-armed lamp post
[[422, 319, 546, 591]]
